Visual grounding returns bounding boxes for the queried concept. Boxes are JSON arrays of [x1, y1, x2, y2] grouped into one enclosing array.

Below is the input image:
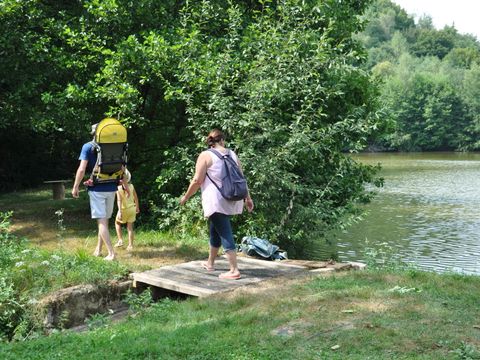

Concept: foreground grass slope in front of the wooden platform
[[0, 270, 480, 359]]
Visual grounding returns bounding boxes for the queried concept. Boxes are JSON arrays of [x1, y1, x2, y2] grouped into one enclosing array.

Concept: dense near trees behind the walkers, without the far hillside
[[0, 0, 382, 255]]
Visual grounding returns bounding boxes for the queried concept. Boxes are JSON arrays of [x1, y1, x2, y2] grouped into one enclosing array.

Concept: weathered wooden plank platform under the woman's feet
[[133, 256, 309, 297]]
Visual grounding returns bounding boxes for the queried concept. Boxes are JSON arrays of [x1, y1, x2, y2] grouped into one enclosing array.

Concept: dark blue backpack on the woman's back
[[207, 149, 248, 201]]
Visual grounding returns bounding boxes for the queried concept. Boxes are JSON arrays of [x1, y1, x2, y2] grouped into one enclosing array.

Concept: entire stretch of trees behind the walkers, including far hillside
[[0, 0, 480, 255]]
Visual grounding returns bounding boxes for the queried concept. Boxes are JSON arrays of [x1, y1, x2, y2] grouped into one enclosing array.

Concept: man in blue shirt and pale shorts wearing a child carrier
[[72, 124, 117, 260]]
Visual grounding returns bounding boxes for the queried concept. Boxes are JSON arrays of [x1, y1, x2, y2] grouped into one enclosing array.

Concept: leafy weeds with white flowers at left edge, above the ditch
[[0, 213, 128, 341]]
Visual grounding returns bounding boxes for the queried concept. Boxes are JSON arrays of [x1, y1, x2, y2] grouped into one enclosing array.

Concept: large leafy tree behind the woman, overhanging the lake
[[159, 1, 380, 255]]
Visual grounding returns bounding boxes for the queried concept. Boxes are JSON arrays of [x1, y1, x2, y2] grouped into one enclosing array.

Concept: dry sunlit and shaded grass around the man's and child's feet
[[0, 187, 208, 270]]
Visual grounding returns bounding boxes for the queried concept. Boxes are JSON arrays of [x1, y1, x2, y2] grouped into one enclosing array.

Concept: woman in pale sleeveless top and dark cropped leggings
[[180, 129, 253, 280]]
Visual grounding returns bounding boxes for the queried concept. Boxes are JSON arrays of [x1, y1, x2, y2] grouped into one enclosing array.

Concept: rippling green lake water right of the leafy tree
[[321, 153, 480, 275]]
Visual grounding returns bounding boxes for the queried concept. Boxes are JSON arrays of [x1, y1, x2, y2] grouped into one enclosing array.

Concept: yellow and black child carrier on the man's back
[[90, 118, 128, 185]]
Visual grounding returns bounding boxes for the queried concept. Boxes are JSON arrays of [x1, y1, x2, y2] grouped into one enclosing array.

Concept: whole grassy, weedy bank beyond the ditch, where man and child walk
[[0, 188, 208, 342]]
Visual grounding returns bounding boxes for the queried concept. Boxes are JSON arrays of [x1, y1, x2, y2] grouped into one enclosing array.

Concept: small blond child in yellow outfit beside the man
[[115, 169, 140, 251]]
